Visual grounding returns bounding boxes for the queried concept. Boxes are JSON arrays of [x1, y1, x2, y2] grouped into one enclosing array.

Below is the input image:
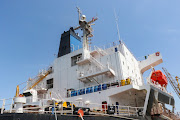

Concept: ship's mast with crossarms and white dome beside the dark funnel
[[74, 7, 97, 50]]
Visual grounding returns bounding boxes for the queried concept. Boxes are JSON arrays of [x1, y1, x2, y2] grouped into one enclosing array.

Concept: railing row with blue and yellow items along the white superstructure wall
[[66, 80, 132, 97]]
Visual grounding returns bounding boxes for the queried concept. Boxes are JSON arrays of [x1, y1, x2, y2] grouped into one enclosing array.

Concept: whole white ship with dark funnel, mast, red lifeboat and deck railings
[[0, 8, 180, 120]]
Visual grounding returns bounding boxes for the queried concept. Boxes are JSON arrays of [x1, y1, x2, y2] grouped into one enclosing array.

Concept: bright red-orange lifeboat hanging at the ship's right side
[[151, 70, 168, 86]]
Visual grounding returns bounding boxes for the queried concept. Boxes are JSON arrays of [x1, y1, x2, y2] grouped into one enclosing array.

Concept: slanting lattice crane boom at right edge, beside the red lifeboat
[[162, 68, 180, 99]]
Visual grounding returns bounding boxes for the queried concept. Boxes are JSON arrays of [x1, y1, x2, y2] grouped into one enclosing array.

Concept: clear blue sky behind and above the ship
[[0, 0, 180, 111]]
